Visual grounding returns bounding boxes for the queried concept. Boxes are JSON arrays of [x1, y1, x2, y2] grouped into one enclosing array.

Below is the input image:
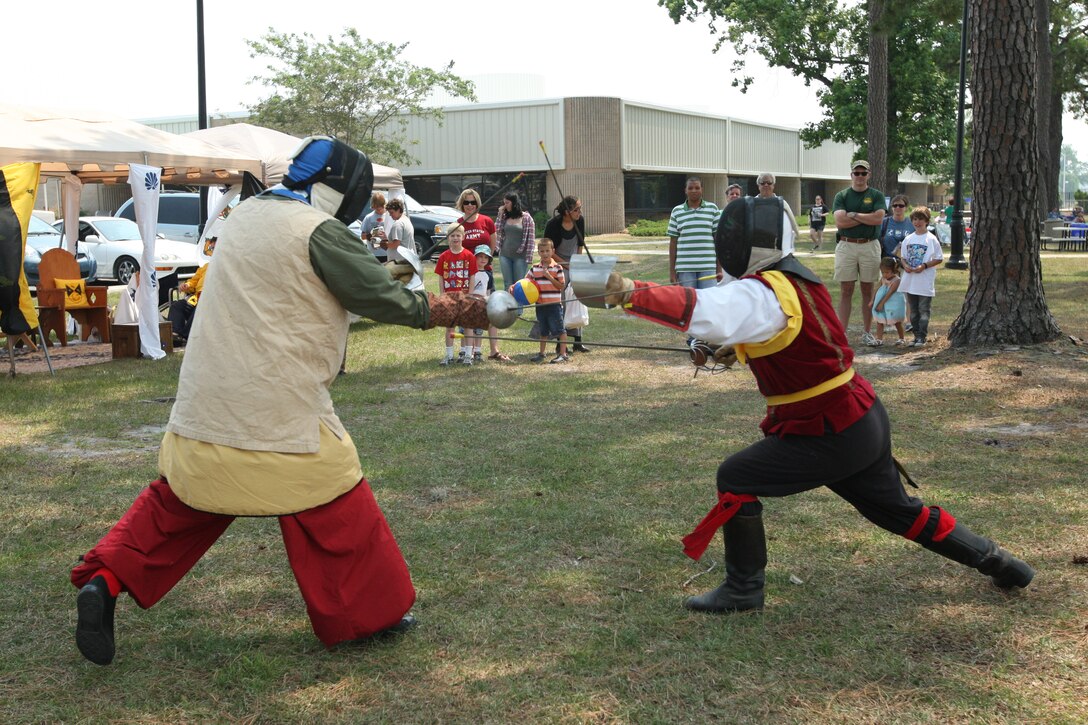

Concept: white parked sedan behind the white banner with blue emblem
[[53, 217, 203, 290]]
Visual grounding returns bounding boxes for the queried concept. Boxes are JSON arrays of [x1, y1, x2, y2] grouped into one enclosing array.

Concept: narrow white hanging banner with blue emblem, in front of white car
[[128, 163, 166, 360]]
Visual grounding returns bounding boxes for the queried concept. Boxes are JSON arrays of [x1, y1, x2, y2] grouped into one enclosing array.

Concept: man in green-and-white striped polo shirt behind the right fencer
[[668, 176, 721, 290]]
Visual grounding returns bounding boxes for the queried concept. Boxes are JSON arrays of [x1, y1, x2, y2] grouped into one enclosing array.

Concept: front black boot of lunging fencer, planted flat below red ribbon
[[683, 515, 767, 612]]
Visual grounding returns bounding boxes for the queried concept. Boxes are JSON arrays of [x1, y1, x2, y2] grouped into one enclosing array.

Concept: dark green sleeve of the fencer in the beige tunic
[[310, 219, 431, 329]]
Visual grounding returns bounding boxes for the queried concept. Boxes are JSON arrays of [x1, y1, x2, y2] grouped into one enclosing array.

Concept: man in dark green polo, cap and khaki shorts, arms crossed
[[831, 160, 888, 345]]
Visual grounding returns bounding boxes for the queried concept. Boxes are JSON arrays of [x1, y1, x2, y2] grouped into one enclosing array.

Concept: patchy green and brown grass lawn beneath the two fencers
[[0, 247, 1088, 723]]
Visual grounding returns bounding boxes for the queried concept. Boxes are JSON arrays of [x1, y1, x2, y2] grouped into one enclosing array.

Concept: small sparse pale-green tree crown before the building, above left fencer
[[246, 28, 475, 164]]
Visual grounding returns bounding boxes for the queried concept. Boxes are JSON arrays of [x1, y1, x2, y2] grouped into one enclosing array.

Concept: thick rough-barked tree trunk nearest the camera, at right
[[947, 0, 1061, 346]]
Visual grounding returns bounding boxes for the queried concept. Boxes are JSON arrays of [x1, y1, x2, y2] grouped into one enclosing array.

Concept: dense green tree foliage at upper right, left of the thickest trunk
[[658, 0, 960, 173]]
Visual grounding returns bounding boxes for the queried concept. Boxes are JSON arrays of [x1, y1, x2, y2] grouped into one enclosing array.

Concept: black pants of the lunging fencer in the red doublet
[[718, 398, 929, 533]]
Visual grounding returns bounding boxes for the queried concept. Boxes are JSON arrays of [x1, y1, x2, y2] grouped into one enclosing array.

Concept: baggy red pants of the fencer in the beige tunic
[[72, 478, 416, 647]]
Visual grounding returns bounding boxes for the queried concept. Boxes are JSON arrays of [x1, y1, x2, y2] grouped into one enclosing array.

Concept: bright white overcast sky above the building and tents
[[3, 0, 1088, 161]]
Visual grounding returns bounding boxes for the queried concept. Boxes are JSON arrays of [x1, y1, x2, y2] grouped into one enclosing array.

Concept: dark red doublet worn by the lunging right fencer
[[744, 274, 876, 435]]
